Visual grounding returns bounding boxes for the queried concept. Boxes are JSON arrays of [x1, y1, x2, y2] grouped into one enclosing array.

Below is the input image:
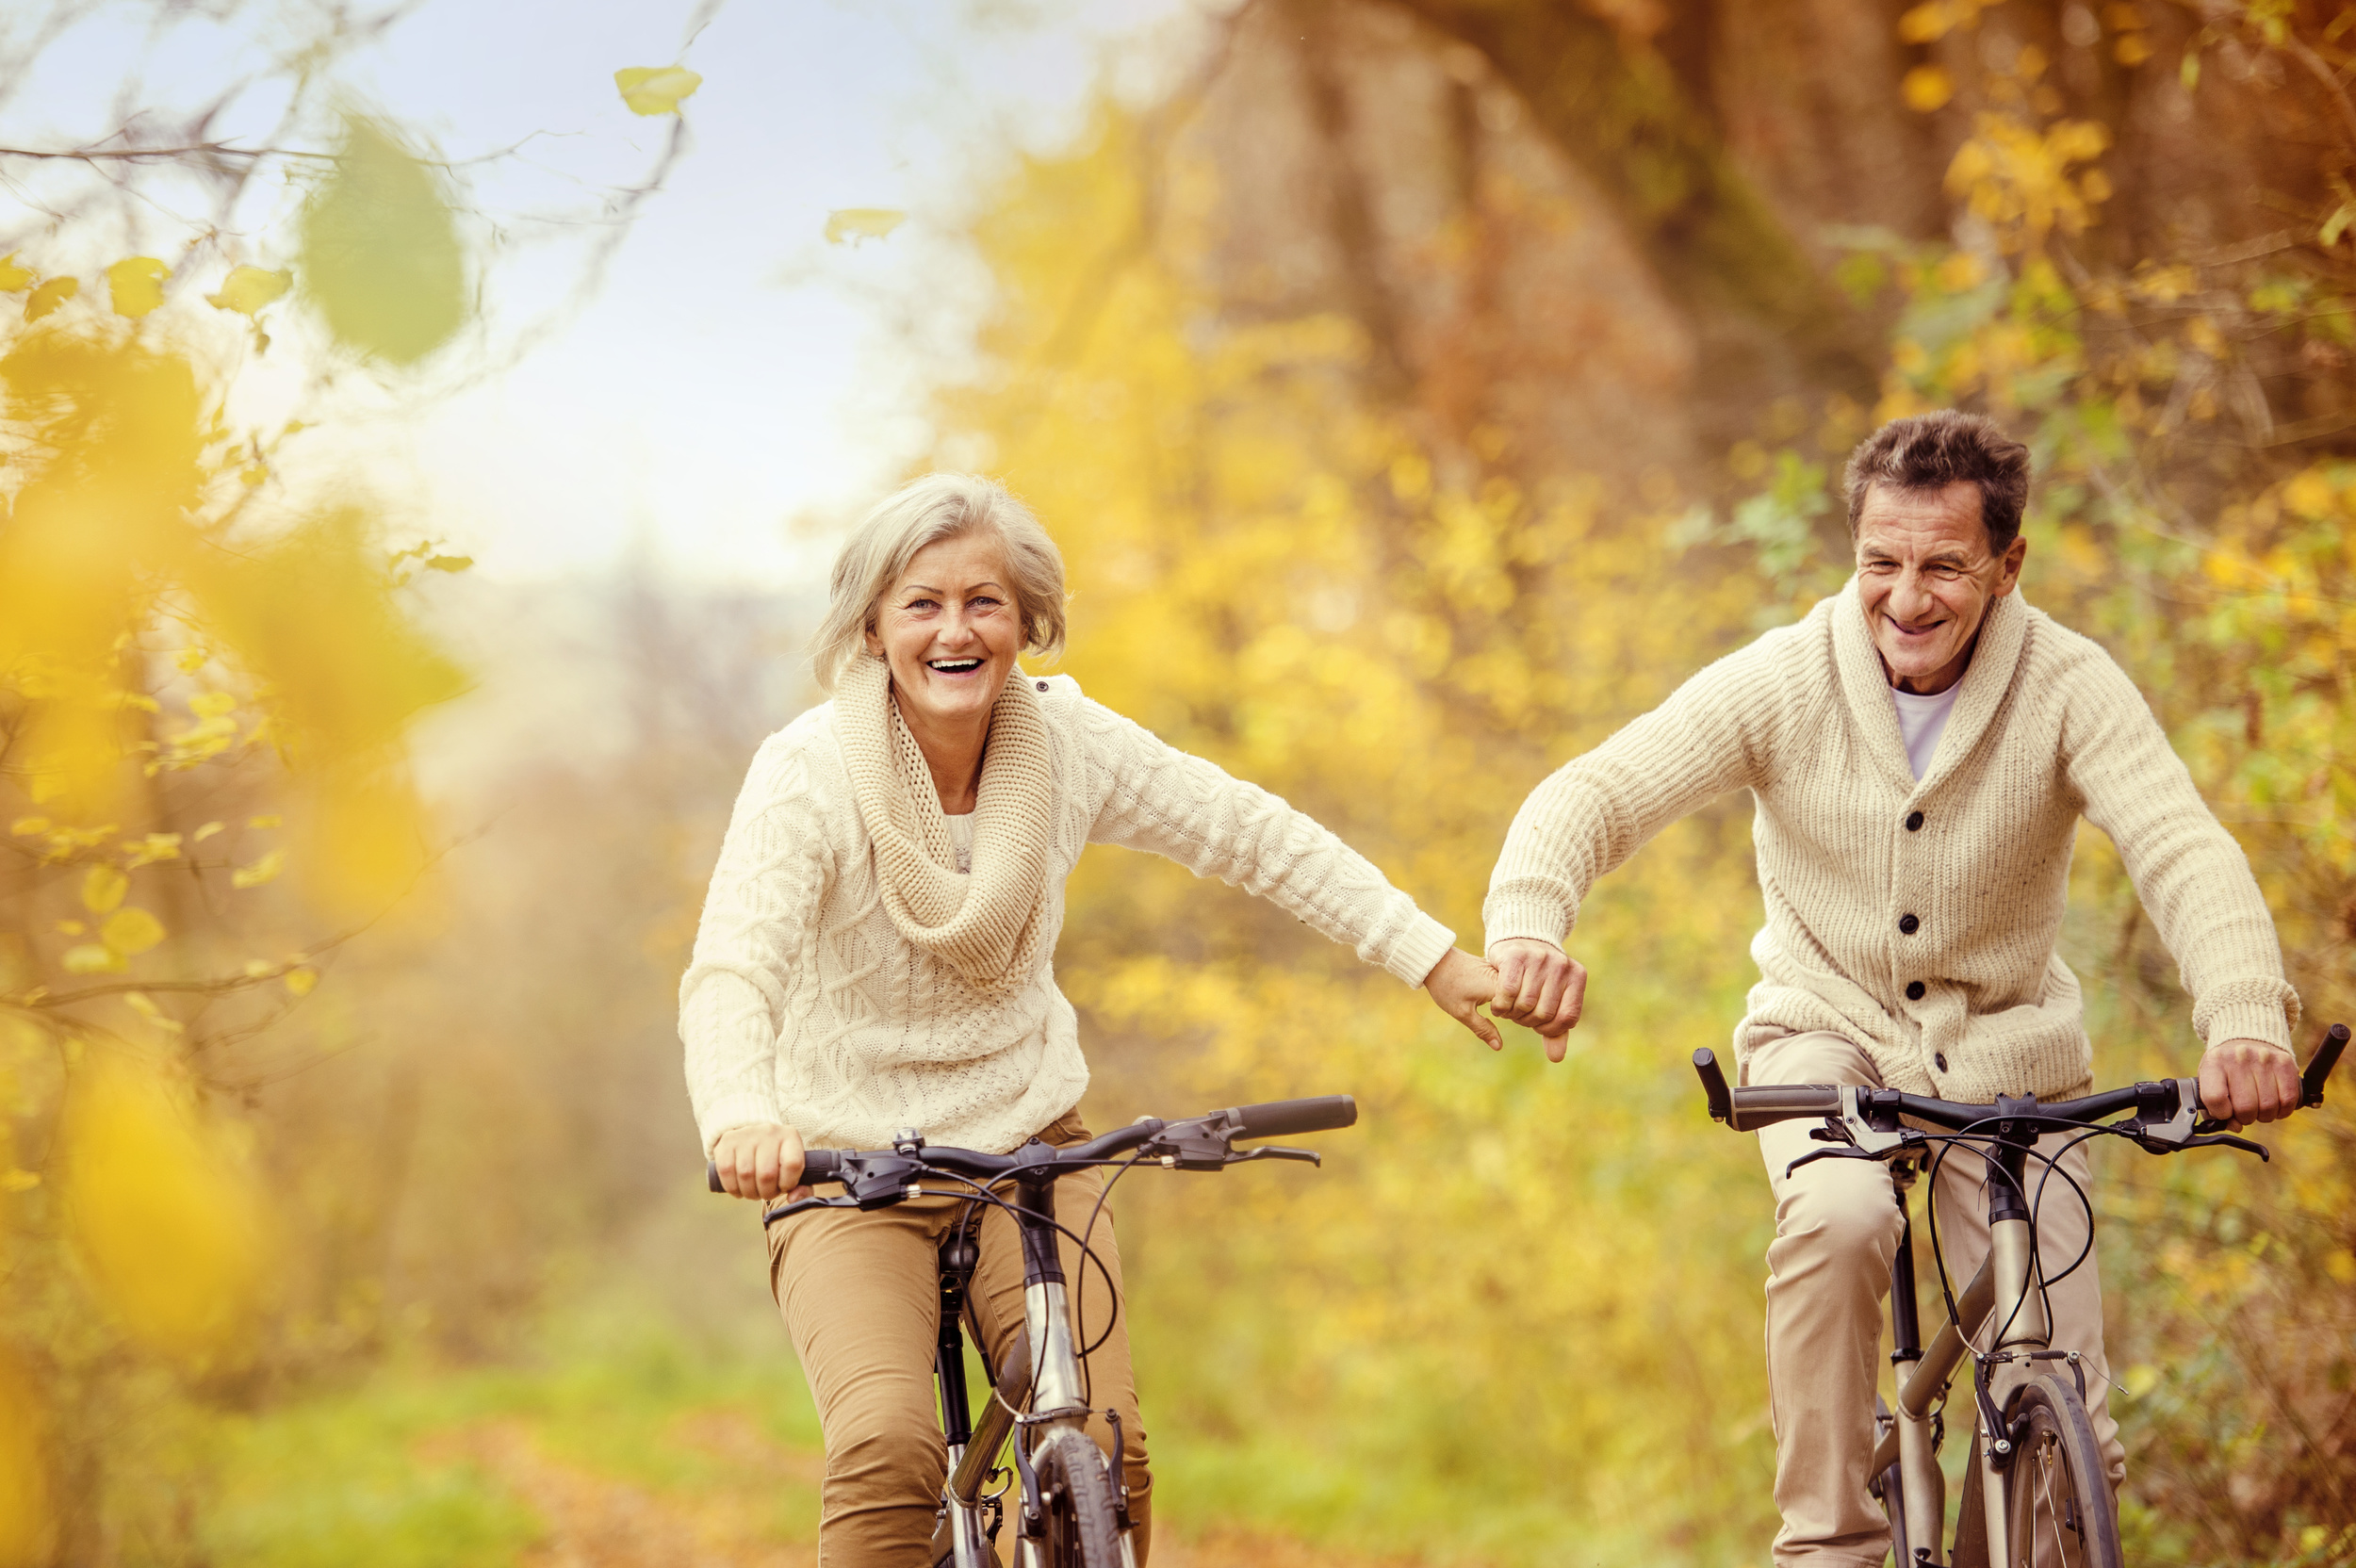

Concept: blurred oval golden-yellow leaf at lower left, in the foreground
[[64, 1053, 267, 1356]]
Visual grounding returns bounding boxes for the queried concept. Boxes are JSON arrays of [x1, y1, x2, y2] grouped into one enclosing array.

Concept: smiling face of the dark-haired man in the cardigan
[[1857, 481, 2029, 694]]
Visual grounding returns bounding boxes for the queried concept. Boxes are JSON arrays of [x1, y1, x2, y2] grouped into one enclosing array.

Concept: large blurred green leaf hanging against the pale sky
[[297, 120, 466, 365]]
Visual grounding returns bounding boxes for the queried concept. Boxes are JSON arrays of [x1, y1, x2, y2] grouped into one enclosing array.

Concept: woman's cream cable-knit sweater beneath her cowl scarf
[[679, 674, 1456, 1152]]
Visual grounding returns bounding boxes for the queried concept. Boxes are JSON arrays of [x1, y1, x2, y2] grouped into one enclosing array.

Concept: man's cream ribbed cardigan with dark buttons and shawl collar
[[1482, 580, 2299, 1102]]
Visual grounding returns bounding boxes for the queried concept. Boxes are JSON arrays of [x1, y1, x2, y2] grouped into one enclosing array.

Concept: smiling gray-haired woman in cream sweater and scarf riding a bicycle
[[679, 473, 1497, 1568]]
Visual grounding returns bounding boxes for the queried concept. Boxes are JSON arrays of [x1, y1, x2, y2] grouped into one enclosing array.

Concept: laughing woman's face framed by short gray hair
[[867, 530, 1023, 730]]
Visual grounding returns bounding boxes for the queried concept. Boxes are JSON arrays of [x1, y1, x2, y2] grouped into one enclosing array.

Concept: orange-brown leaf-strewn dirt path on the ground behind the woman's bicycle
[[448, 1413, 1414, 1568]]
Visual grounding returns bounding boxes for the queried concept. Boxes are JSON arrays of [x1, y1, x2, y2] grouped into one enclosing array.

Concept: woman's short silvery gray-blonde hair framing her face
[[810, 473, 1063, 693]]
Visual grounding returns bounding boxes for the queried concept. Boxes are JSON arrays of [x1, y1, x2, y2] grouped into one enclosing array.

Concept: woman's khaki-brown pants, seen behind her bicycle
[[768, 1114, 1153, 1568]]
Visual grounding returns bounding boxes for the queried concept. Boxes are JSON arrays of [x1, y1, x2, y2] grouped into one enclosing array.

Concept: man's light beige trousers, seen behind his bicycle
[[1743, 1034, 2125, 1568]]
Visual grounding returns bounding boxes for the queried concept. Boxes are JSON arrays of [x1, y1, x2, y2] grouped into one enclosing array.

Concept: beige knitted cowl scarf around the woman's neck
[[834, 655, 1055, 998]]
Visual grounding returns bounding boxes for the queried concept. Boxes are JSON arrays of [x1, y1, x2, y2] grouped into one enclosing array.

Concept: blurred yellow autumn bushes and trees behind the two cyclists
[[0, 0, 2356, 1566]]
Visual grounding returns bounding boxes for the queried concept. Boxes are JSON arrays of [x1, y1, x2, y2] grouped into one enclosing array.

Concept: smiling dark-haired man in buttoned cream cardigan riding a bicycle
[[1482, 412, 2299, 1566]]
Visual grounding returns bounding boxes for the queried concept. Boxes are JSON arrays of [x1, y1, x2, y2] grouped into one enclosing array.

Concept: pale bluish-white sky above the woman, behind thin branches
[[0, 0, 1192, 584]]
